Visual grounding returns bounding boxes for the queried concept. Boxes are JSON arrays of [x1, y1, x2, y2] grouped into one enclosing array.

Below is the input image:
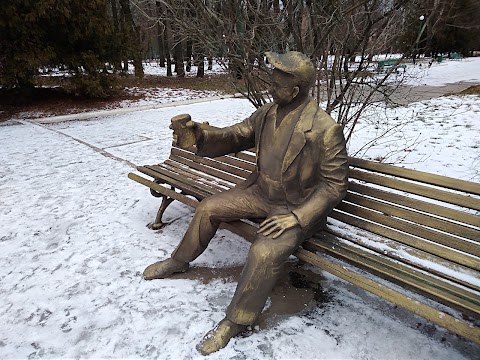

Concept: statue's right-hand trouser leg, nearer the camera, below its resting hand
[[226, 227, 305, 325]]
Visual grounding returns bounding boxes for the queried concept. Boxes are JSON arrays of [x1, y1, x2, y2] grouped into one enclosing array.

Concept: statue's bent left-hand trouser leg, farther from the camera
[[172, 187, 268, 262]]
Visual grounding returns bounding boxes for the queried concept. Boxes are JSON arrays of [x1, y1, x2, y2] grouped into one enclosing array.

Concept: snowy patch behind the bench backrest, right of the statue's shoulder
[[349, 95, 480, 182]]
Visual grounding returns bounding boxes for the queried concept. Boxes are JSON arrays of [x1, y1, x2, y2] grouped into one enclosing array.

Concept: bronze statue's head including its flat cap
[[265, 51, 315, 103]]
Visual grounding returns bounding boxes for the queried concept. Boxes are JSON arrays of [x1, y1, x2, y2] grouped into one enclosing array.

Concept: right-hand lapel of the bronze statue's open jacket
[[282, 98, 317, 174]]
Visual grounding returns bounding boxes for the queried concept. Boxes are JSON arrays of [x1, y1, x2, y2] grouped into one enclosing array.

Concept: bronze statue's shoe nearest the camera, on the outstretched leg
[[197, 318, 246, 355]]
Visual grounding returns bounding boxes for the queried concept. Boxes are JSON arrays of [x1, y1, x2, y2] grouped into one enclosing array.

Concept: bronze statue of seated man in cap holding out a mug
[[144, 51, 348, 354]]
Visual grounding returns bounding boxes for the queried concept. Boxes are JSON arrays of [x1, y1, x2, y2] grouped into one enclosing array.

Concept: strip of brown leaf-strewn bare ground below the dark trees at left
[[0, 75, 239, 122]]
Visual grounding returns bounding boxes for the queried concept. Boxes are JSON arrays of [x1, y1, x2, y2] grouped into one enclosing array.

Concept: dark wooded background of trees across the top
[[0, 0, 480, 136]]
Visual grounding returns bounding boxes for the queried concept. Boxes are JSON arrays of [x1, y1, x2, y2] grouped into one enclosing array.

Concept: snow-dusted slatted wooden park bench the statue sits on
[[128, 126, 480, 344]]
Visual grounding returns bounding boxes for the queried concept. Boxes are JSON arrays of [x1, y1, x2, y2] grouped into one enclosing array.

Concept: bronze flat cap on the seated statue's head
[[265, 51, 315, 83]]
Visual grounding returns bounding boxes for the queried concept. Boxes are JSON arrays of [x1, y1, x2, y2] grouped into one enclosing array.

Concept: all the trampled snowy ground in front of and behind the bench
[[0, 60, 480, 360]]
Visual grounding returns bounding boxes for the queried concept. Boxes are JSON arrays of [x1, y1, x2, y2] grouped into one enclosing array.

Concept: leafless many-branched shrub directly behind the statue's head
[[132, 0, 458, 155]]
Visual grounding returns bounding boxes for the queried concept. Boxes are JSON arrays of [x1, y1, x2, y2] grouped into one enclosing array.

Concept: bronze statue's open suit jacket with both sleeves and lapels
[[197, 97, 348, 233]]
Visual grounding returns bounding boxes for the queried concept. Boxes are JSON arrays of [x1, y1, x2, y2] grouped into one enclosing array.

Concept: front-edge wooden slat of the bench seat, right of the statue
[[295, 249, 480, 343]]
